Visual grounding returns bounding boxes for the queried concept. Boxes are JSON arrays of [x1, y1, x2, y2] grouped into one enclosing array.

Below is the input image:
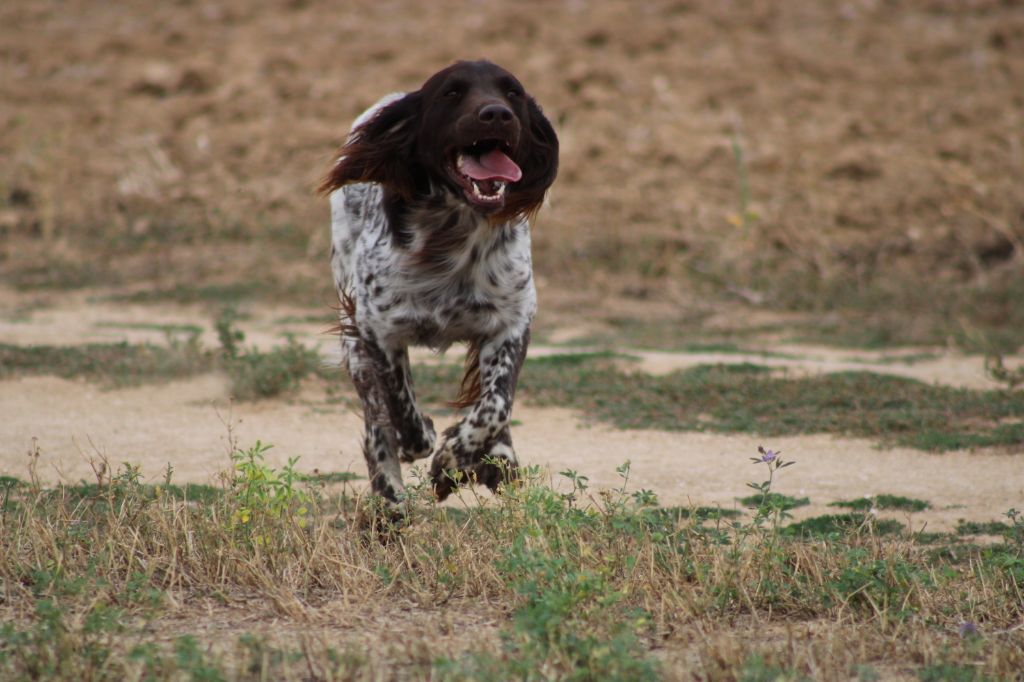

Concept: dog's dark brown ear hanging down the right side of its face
[[498, 97, 558, 220]]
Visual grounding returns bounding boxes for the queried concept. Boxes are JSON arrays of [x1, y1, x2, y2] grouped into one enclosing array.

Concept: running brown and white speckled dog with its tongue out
[[319, 60, 558, 505]]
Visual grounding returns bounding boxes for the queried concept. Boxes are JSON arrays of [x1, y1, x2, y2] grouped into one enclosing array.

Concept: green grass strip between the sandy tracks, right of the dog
[[501, 355, 1024, 452]]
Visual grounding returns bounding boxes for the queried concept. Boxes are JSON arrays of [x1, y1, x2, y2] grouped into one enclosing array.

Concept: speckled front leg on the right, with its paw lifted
[[430, 329, 529, 500]]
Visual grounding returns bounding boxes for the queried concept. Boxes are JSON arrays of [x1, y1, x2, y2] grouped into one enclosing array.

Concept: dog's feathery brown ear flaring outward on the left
[[316, 91, 423, 199]]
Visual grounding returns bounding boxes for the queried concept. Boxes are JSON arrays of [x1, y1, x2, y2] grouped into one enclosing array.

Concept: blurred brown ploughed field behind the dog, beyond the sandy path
[[0, 0, 1024, 351]]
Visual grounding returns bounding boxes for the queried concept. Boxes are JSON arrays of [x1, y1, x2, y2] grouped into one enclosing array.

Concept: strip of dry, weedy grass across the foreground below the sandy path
[[0, 445, 1024, 680]]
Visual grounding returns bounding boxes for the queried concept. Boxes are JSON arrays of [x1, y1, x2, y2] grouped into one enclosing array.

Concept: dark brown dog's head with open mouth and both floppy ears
[[319, 61, 558, 219]]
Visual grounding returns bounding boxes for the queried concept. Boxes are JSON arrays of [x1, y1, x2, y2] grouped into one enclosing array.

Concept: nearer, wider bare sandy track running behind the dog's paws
[[0, 366, 1024, 529]]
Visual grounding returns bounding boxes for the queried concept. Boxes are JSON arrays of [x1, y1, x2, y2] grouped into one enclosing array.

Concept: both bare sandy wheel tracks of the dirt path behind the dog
[[0, 290, 1024, 529]]
